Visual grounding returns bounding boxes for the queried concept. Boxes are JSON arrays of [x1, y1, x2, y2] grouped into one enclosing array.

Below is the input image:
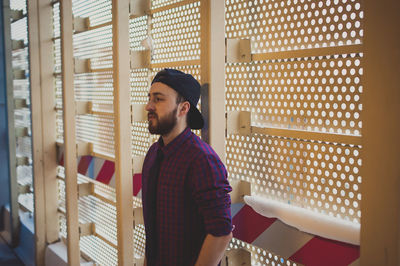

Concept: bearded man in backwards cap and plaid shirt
[[142, 69, 232, 266]]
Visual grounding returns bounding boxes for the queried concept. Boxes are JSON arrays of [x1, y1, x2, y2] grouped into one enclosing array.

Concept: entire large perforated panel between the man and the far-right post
[[225, 0, 363, 265]]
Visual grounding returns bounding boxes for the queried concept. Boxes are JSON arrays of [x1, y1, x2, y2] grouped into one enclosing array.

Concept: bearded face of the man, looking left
[[146, 82, 178, 136]]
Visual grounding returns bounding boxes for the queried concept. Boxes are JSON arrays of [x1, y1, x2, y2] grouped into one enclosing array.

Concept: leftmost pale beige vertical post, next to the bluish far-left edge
[[27, 0, 46, 265]]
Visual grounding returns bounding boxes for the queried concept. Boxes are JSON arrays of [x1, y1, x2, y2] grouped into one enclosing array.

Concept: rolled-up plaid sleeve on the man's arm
[[188, 154, 232, 236]]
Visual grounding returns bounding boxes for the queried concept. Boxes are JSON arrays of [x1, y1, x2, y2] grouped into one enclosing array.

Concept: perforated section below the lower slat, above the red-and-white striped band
[[226, 135, 362, 220]]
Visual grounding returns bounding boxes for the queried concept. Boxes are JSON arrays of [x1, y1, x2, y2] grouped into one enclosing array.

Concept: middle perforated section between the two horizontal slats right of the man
[[226, 54, 363, 135]]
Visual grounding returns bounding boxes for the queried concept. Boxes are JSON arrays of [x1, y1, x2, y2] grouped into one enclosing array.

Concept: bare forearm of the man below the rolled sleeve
[[195, 233, 232, 266]]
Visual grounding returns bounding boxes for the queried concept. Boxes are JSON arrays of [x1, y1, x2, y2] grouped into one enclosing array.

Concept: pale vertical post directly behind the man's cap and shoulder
[[200, 0, 225, 162]]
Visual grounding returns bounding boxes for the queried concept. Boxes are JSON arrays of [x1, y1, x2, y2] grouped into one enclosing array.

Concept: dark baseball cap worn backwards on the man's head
[[151, 68, 204, 129]]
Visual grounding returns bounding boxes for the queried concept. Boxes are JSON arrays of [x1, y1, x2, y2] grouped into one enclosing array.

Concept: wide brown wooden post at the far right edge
[[361, 0, 400, 265]]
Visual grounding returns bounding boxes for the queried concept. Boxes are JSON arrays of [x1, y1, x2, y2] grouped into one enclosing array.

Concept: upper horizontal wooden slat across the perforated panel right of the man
[[252, 44, 363, 61]]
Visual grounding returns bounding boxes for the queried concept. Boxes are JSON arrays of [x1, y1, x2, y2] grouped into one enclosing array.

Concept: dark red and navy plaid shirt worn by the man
[[142, 128, 232, 265]]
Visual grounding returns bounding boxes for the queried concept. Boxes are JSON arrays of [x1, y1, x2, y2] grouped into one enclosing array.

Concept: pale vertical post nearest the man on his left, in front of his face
[[112, 0, 133, 265]]
